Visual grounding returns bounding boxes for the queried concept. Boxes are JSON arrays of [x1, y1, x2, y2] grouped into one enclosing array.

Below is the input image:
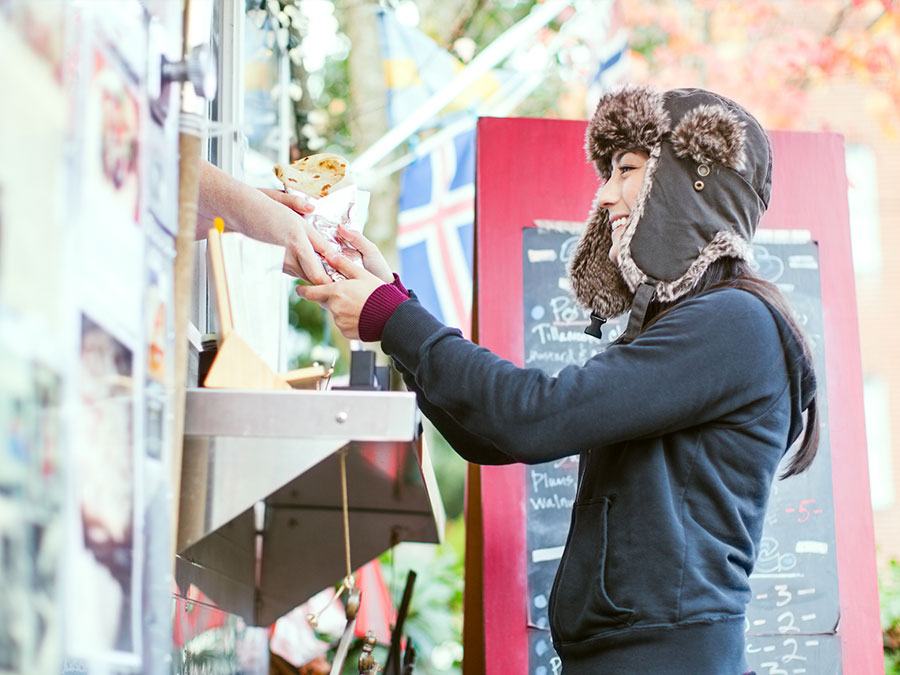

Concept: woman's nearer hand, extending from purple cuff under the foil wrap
[[297, 253, 382, 340]]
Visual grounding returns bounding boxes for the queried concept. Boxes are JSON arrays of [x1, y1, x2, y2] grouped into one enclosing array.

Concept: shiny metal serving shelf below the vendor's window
[[176, 389, 444, 625]]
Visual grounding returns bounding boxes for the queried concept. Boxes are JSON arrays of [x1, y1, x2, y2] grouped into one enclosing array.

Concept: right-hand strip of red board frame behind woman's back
[[761, 132, 884, 673]]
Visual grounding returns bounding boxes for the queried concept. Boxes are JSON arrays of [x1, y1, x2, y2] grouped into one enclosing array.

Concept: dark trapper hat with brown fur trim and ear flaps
[[569, 86, 772, 339]]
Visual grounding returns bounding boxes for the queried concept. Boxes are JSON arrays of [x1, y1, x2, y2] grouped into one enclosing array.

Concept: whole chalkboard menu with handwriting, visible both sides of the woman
[[522, 227, 842, 675]]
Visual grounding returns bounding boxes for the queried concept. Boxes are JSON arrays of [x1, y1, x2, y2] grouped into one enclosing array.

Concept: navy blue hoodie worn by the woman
[[382, 289, 815, 675]]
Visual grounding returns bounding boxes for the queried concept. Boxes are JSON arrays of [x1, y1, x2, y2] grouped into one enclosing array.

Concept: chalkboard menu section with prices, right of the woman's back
[[747, 233, 842, 675]]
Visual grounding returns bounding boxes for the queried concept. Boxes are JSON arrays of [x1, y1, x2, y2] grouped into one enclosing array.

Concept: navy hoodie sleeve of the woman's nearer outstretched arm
[[382, 290, 788, 463]]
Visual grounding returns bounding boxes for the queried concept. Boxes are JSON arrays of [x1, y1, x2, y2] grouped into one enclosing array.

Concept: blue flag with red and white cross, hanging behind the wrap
[[397, 129, 475, 336]]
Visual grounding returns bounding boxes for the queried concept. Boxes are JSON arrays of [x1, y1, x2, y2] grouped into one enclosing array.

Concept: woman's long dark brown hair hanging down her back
[[641, 257, 819, 479]]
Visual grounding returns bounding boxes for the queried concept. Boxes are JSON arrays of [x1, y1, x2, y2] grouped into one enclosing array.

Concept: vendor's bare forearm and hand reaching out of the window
[[197, 160, 330, 284]]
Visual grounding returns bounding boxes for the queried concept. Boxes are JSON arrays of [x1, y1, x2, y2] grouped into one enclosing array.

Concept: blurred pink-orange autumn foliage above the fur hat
[[621, 0, 900, 137]]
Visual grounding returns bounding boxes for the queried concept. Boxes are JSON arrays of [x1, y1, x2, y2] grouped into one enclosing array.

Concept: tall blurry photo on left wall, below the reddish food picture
[[66, 315, 140, 657]]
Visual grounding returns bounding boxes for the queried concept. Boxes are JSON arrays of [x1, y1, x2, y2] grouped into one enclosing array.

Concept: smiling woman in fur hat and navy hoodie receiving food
[[299, 87, 818, 675]]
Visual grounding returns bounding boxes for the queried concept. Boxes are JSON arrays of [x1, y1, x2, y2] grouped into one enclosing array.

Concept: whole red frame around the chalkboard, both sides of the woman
[[476, 118, 883, 675]]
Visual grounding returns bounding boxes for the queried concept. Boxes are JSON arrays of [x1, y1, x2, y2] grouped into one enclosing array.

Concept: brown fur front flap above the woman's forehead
[[584, 85, 669, 178]]
